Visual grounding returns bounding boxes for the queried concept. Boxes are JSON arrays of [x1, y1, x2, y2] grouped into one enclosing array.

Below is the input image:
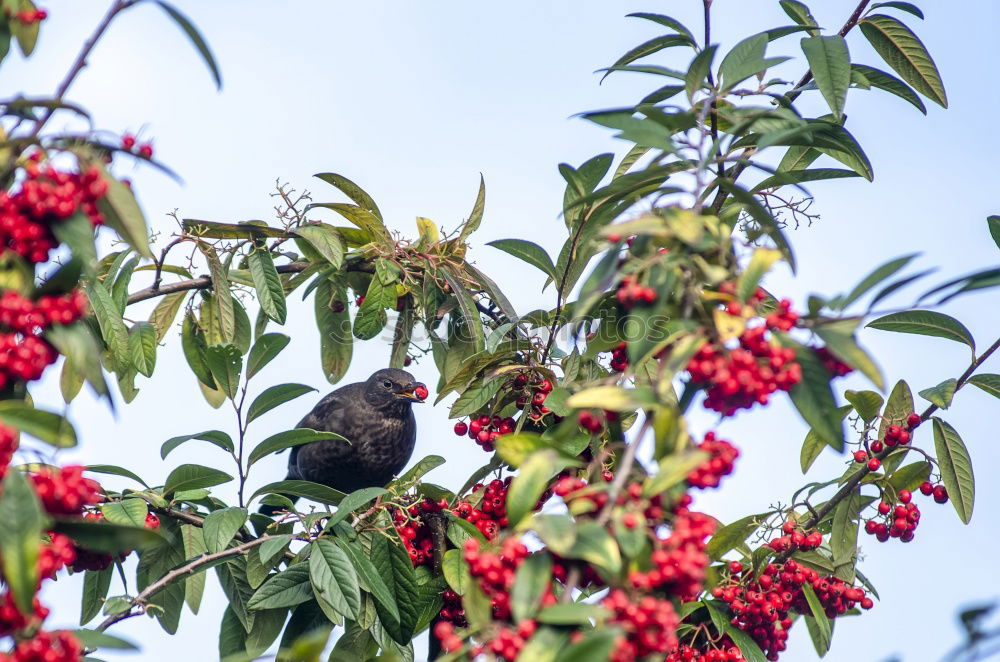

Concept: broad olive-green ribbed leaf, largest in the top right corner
[[858, 14, 948, 108]]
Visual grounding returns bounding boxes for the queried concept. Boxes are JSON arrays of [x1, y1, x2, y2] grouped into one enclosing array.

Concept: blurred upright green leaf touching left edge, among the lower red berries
[[0, 469, 43, 614]]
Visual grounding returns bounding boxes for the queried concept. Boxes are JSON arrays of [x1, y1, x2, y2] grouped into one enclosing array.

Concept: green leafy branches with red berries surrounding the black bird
[[0, 0, 1000, 662]]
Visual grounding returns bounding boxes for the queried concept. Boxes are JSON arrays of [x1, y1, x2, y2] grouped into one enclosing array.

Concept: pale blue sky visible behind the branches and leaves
[[0, 0, 1000, 662]]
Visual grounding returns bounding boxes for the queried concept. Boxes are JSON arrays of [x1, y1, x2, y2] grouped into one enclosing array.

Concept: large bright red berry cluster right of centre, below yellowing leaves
[[687, 327, 802, 416]]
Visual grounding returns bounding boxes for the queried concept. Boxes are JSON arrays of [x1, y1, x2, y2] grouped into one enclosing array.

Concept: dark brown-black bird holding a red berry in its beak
[[260, 368, 427, 515]]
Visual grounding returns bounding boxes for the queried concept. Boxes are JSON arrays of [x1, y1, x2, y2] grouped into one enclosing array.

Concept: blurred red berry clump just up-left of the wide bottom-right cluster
[[628, 506, 717, 601]]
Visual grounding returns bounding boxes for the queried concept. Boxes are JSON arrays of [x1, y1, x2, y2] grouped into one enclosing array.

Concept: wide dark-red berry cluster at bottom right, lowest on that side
[[712, 560, 872, 660]]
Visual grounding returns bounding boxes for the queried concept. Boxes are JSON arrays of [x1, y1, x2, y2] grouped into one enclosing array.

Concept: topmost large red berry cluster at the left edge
[[0, 163, 108, 263]]
